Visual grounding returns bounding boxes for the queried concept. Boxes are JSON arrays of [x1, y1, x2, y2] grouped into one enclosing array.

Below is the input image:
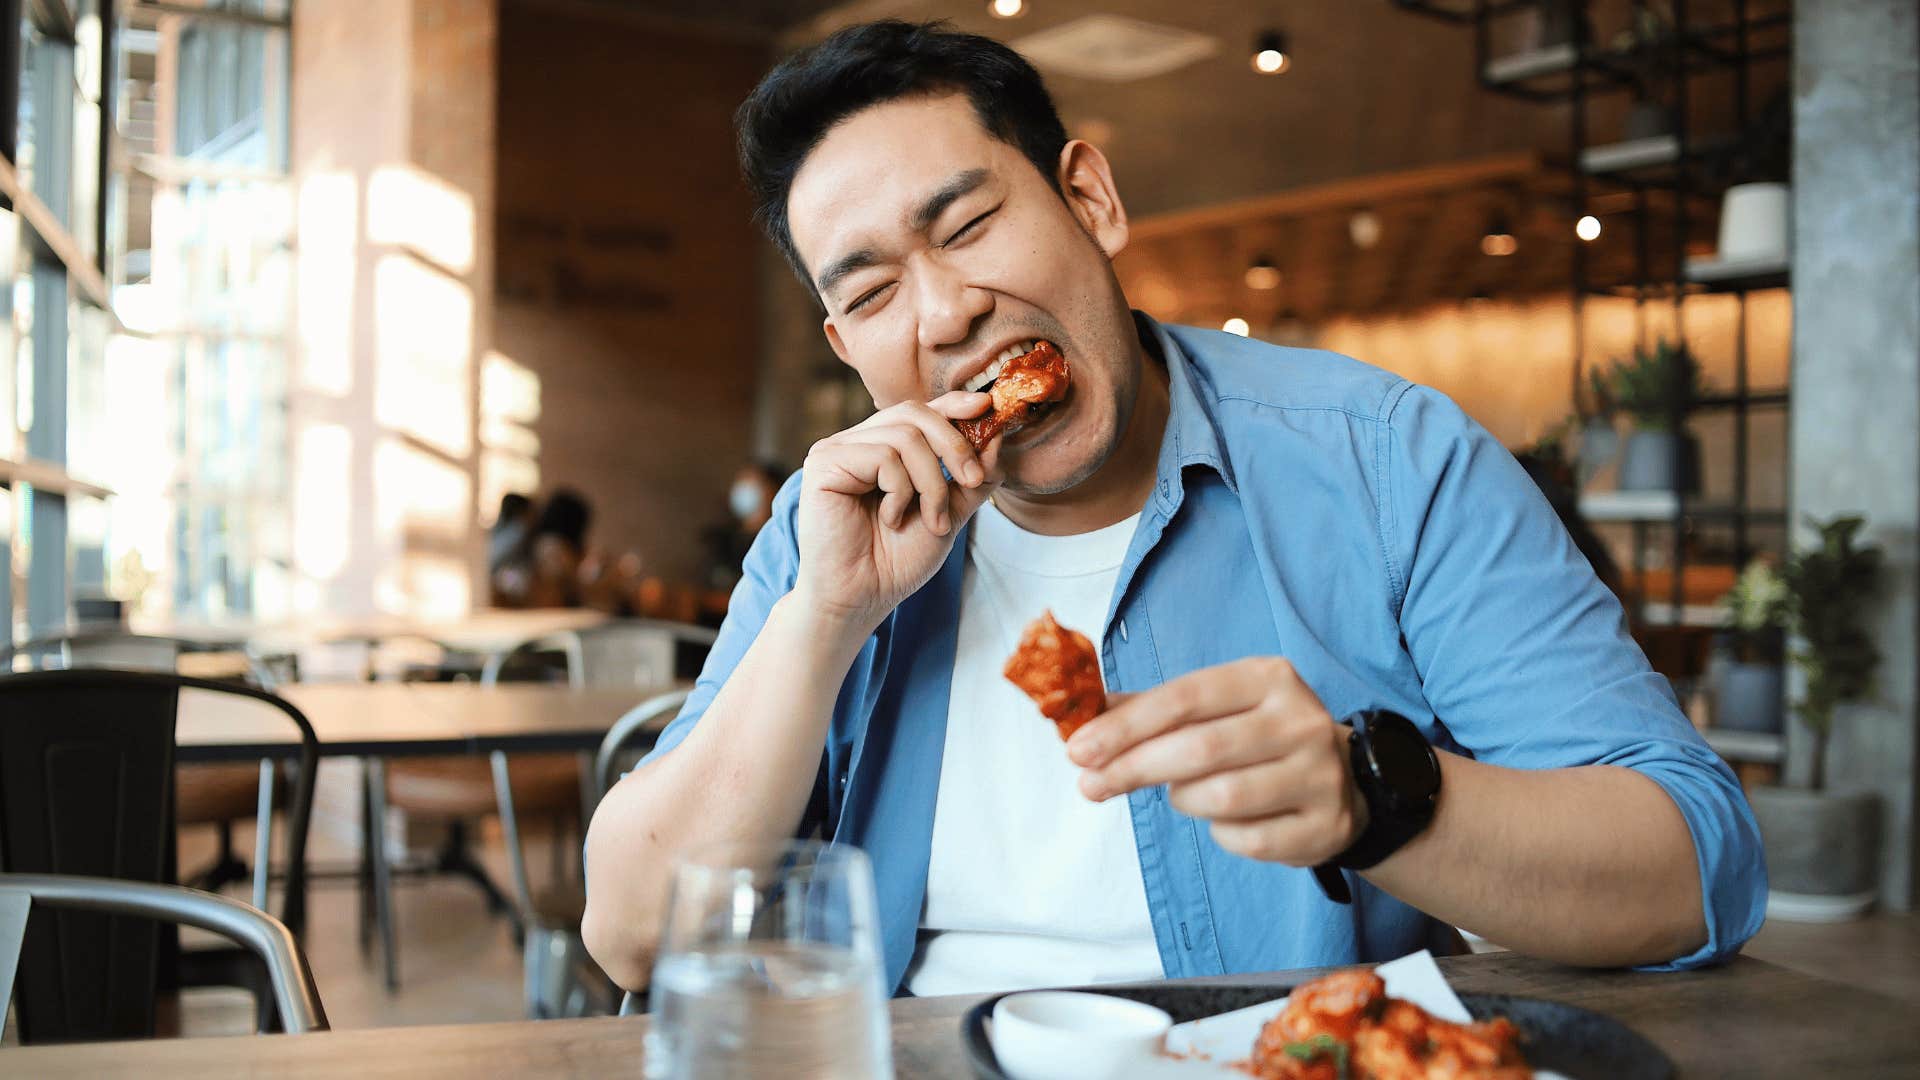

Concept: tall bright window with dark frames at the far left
[[0, 0, 292, 638]]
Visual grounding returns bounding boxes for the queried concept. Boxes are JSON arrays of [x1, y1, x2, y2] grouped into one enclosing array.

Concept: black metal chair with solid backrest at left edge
[[0, 669, 319, 1042]]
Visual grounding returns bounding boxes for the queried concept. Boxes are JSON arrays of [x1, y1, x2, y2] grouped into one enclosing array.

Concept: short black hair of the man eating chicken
[[733, 19, 1068, 290]]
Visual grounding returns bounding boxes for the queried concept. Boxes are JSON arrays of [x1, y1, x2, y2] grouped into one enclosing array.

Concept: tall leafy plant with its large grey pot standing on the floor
[[1751, 517, 1882, 922]]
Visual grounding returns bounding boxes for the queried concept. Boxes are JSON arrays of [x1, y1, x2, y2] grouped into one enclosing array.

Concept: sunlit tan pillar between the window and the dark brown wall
[[290, 0, 499, 615]]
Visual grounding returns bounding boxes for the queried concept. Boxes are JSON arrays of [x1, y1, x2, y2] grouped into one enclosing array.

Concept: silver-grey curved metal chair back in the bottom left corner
[[0, 874, 326, 1042]]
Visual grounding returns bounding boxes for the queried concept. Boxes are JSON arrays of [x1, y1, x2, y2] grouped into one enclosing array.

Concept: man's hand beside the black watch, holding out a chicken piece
[[1068, 657, 1367, 867]]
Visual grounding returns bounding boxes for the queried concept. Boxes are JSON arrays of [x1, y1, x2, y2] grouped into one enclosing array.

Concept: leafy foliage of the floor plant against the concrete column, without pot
[[1784, 515, 1884, 790]]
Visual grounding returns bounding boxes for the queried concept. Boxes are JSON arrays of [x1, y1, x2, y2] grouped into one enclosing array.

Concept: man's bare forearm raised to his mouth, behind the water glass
[[582, 594, 866, 986]]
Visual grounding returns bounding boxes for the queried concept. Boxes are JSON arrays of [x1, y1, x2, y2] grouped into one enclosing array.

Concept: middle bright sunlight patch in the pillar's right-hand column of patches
[[372, 254, 472, 457]]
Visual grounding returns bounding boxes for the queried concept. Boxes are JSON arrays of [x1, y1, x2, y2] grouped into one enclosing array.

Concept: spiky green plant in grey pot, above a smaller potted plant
[[1613, 338, 1701, 494]]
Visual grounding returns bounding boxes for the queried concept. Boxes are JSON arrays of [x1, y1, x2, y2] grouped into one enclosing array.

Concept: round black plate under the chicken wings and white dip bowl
[[960, 986, 1674, 1080]]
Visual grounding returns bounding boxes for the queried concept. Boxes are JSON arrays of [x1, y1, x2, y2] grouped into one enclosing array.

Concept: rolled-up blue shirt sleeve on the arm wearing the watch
[[1379, 388, 1766, 970]]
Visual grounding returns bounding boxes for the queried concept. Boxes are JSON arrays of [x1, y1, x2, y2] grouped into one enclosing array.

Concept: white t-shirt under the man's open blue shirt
[[906, 503, 1162, 995]]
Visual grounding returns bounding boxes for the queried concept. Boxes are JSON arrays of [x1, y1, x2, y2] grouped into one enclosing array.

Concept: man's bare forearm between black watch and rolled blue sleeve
[[1365, 753, 1707, 965]]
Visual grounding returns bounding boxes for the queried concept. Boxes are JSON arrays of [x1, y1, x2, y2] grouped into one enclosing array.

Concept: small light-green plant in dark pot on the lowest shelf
[[1713, 559, 1791, 734]]
